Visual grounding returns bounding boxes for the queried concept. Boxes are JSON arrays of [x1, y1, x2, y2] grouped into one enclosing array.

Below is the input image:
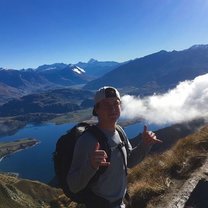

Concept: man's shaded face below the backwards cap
[[96, 98, 121, 122]]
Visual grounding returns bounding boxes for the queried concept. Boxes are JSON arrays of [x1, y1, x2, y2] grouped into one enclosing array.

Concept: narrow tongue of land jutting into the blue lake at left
[[0, 138, 38, 159]]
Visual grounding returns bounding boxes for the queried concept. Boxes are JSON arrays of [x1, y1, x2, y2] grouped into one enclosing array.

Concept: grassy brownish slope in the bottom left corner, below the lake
[[0, 174, 72, 208]]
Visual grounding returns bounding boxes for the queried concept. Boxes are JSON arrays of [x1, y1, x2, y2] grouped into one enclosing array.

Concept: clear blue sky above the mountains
[[0, 0, 208, 69]]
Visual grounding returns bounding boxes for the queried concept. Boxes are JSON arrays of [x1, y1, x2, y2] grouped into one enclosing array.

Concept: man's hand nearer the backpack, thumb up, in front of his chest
[[91, 142, 110, 169]]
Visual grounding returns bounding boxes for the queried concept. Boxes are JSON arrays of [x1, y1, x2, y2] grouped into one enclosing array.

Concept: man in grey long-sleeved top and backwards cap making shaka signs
[[67, 86, 161, 208]]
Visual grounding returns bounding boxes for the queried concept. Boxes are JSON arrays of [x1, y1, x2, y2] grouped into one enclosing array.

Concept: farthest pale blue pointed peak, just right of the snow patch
[[76, 59, 122, 78]]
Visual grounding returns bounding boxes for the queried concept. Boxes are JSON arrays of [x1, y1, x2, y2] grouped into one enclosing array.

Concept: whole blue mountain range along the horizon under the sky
[[0, 45, 208, 101]]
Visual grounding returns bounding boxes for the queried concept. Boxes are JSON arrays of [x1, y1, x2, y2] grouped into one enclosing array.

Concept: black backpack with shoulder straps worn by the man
[[53, 122, 129, 203]]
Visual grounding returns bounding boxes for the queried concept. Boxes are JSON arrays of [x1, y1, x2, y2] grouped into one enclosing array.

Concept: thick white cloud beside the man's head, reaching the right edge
[[121, 74, 208, 124]]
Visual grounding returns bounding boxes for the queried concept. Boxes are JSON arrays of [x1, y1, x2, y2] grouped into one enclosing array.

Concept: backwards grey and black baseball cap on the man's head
[[92, 86, 121, 116]]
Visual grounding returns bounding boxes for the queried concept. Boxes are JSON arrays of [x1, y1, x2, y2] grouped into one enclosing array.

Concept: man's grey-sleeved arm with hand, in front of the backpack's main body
[[67, 133, 110, 193]]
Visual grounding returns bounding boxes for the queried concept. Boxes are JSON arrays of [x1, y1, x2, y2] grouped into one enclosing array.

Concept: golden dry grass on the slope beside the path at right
[[128, 126, 208, 208]]
